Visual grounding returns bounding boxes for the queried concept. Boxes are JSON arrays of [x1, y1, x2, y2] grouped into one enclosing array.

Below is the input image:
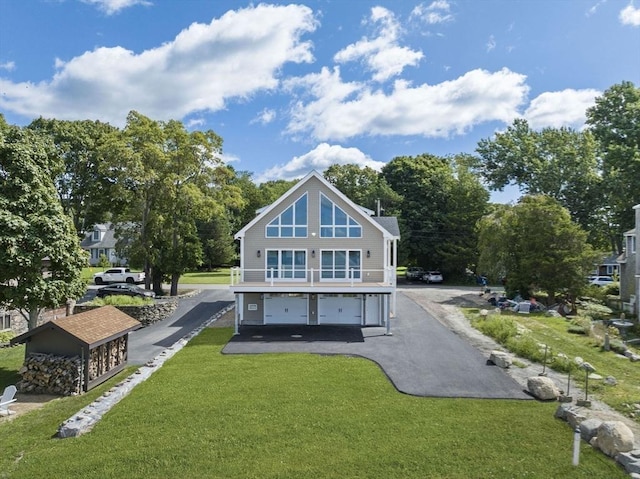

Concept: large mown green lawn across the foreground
[[0, 329, 626, 479]]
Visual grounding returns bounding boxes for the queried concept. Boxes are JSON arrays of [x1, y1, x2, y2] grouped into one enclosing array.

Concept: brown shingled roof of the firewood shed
[[11, 306, 141, 349]]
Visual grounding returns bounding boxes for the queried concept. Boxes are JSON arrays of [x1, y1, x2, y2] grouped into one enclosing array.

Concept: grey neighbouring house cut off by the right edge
[[618, 205, 640, 321]]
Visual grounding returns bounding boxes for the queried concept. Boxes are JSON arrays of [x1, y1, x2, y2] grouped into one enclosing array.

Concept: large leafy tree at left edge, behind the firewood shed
[[0, 115, 87, 329]]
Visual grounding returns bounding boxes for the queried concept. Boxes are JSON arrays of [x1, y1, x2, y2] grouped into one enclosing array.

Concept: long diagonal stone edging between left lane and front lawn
[[56, 304, 235, 438]]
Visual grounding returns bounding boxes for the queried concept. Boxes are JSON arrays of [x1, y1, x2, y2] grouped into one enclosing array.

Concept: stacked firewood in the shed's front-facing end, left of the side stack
[[16, 353, 82, 396]]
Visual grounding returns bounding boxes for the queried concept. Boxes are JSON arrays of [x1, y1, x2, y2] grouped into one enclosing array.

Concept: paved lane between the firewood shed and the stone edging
[[128, 286, 233, 364]]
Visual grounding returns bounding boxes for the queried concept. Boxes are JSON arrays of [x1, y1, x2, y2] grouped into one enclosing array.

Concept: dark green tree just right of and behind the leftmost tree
[[29, 118, 120, 231]]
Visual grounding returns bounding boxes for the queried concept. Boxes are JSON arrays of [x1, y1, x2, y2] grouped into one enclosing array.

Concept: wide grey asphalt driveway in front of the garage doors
[[223, 291, 531, 399]]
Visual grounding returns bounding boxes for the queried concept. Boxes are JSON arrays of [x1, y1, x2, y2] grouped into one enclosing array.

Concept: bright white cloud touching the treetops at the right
[[523, 89, 602, 130]]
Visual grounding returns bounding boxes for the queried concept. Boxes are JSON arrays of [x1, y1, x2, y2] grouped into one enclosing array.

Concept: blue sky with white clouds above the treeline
[[0, 0, 640, 201]]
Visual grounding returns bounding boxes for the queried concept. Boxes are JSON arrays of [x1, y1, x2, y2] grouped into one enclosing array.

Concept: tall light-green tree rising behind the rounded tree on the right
[[476, 119, 608, 246]]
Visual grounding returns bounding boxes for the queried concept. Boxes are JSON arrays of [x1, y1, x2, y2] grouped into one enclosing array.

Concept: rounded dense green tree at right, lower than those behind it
[[478, 195, 595, 303]]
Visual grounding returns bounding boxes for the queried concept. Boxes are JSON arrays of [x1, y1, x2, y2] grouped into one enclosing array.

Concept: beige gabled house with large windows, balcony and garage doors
[[231, 171, 400, 333]]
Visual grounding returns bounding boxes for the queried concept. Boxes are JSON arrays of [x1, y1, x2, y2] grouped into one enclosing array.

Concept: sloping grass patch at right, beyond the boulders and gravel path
[[467, 310, 640, 420]]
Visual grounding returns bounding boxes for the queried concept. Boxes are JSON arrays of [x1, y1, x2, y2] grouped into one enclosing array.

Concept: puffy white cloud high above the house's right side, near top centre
[[333, 7, 424, 82]]
